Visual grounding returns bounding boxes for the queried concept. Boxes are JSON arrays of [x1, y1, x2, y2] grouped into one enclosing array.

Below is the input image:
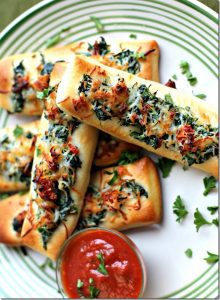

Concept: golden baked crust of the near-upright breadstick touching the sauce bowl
[[21, 99, 98, 260]]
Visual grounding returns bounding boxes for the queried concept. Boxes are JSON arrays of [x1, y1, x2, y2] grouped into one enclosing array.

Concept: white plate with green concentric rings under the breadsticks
[[0, 0, 218, 299]]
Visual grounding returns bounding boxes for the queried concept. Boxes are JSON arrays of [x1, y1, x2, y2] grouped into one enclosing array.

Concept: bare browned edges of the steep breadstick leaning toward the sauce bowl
[[22, 114, 98, 260]]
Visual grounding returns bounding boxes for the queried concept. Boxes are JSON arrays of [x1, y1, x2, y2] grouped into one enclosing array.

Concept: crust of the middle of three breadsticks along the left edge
[[0, 120, 40, 192]]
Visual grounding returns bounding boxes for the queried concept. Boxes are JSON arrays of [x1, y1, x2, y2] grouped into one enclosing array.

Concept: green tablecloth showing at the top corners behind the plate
[[0, 0, 219, 31]]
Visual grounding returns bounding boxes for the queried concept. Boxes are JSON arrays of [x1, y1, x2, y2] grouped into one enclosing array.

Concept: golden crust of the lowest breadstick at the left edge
[[0, 193, 30, 246]]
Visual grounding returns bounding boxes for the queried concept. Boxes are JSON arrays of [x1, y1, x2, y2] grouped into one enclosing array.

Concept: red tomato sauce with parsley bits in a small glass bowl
[[60, 229, 143, 298]]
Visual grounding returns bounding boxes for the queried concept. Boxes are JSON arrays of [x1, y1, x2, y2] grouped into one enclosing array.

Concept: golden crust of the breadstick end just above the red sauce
[[82, 157, 162, 230]]
